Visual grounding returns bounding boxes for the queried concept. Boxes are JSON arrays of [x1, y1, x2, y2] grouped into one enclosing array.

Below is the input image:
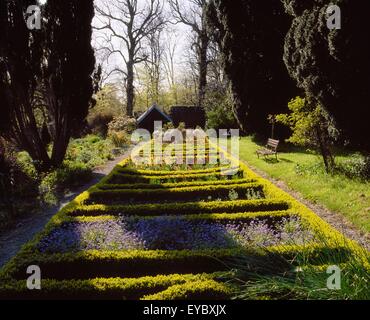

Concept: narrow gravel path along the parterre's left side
[[0, 150, 130, 268]]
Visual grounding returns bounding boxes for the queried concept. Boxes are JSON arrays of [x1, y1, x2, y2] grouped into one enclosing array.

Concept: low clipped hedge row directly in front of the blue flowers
[[2, 244, 351, 283]]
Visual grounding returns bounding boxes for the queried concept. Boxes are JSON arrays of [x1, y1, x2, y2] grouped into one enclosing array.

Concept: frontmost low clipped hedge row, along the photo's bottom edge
[[0, 273, 231, 300]]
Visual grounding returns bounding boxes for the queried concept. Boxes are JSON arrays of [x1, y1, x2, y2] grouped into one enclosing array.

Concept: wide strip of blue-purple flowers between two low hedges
[[37, 216, 314, 253]]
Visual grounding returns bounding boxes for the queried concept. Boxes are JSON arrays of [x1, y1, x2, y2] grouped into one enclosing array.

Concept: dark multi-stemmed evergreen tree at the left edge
[[0, 0, 95, 171]]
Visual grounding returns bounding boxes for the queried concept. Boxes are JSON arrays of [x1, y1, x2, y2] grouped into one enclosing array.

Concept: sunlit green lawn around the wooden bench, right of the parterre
[[240, 137, 370, 232]]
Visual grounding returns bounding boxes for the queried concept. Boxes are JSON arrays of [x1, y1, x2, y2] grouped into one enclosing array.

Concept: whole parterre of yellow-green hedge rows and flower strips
[[0, 141, 366, 299]]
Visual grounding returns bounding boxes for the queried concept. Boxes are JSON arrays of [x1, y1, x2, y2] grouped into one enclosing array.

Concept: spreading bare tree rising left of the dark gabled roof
[[95, 0, 165, 117]]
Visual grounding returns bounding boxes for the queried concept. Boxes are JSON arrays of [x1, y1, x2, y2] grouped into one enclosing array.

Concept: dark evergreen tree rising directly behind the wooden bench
[[208, 0, 297, 135]]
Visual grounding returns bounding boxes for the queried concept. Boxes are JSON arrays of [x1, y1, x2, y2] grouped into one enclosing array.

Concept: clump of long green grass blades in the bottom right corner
[[229, 235, 370, 300]]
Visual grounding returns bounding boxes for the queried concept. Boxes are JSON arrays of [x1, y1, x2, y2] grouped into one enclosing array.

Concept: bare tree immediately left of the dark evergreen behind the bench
[[169, 0, 210, 107]]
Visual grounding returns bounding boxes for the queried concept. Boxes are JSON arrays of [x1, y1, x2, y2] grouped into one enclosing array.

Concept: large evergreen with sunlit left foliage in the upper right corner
[[283, 0, 370, 151]]
